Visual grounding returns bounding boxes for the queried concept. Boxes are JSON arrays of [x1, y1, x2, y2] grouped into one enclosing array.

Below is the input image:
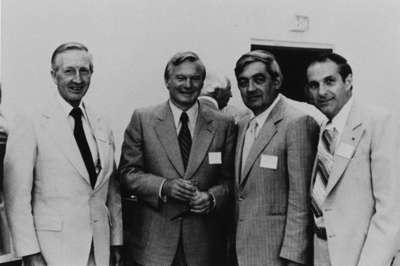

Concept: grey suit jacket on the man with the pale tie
[[235, 99, 319, 266]]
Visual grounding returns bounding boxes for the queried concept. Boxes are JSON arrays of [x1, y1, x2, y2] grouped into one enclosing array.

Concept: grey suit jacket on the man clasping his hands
[[119, 102, 236, 266]]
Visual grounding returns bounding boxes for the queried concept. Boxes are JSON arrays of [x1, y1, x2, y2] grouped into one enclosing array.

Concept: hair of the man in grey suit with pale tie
[[235, 50, 283, 82]]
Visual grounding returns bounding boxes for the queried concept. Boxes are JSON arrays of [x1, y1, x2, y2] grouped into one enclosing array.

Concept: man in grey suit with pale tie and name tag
[[235, 50, 318, 266]]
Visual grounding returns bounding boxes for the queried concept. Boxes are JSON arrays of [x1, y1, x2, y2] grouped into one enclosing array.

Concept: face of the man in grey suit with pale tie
[[237, 62, 280, 115]]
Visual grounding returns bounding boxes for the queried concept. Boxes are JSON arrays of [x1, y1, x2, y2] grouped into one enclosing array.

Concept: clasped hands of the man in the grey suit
[[162, 178, 212, 213]]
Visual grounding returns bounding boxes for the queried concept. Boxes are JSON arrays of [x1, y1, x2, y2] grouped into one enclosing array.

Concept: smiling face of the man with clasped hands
[[166, 61, 204, 110]]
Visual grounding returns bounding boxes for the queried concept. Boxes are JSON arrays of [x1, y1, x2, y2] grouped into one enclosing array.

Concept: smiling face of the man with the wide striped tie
[[307, 59, 352, 119]]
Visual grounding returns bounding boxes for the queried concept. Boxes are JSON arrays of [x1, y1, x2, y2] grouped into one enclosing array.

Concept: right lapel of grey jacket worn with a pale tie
[[241, 100, 284, 186]]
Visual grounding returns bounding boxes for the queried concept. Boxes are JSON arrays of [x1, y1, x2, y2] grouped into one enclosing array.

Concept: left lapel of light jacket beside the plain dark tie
[[42, 101, 90, 184]]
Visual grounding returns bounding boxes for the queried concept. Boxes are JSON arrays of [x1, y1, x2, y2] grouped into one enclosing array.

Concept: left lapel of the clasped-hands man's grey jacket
[[154, 102, 184, 177]]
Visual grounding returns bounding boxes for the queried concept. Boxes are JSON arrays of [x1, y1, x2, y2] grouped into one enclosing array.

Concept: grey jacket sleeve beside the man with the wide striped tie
[[280, 116, 319, 265]]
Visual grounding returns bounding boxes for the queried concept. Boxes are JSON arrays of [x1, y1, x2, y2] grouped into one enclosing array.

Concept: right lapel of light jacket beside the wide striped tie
[[326, 105, 365, 195]]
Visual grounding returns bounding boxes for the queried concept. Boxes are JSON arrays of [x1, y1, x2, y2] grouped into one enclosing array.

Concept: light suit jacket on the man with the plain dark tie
[[4, 99, 122, 265]]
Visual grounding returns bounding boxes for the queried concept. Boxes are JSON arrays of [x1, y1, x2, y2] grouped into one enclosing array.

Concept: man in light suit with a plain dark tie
[[4, 43, 122, 265]]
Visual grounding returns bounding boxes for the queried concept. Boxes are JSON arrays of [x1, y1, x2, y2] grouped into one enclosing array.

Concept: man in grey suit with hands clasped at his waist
[[119, 52, 236, 266]]
